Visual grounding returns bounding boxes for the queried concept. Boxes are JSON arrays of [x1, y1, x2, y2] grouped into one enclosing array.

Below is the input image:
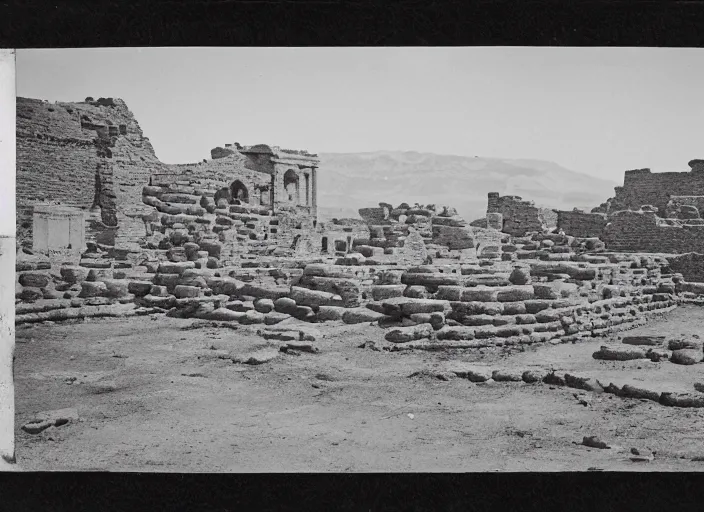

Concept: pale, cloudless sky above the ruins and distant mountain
[[16, 47, 704, 182]]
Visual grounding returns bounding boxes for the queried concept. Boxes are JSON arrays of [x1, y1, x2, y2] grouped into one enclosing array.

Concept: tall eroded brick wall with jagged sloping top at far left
[[16, 98, 163, 248]]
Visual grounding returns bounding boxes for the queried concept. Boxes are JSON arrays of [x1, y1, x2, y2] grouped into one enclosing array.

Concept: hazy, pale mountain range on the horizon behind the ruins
[[318, 151, 618, 221]]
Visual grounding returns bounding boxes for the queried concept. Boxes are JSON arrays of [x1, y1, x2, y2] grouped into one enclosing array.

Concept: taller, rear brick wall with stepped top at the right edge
[[602, 160, 704, 214]]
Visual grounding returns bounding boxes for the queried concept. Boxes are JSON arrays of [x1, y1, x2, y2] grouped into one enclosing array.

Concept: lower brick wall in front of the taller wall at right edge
[[602, 211, 704, 254]]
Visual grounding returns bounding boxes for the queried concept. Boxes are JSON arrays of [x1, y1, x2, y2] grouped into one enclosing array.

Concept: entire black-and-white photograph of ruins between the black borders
[[0, 46, 704, 473]]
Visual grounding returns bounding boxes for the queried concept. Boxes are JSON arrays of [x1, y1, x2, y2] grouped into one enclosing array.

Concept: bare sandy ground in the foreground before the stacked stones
[[9, 307, 704, 472]]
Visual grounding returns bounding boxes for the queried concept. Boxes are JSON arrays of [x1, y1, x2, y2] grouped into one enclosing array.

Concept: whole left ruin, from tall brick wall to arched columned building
[[16, 98, 318, 257]]
